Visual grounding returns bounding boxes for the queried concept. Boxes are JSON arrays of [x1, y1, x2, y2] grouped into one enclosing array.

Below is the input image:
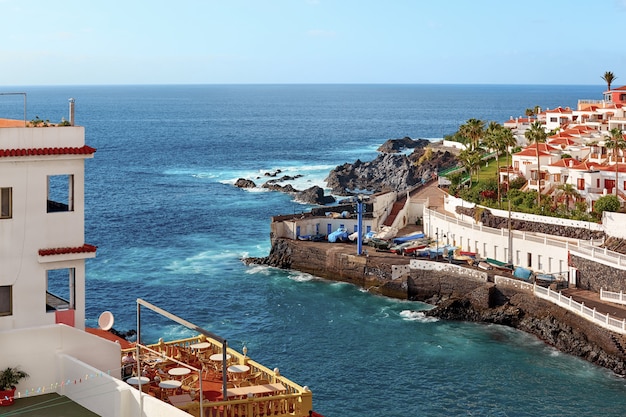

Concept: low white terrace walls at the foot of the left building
[[0, 325, 189, 417]]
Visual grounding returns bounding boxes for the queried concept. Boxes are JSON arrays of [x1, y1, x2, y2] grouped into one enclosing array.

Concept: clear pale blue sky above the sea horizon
[[0, 0, 626, 87]]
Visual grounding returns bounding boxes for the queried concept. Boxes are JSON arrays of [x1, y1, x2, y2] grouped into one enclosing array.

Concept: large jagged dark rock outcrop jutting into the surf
[[326, 149, 456, 195]]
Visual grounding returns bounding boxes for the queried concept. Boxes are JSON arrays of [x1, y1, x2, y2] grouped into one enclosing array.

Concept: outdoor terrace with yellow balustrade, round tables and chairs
[[121, 335, 311, 417]]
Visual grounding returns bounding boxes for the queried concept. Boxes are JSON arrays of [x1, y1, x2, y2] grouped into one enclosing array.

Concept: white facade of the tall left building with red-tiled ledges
[[0, 127, 94, 330]]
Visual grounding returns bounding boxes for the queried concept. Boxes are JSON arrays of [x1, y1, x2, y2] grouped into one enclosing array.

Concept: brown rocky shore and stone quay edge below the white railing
[[244, 239, 626, 376]]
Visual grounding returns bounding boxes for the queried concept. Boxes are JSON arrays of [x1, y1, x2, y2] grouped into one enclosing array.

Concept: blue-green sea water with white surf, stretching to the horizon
[[0, 85, 626, 417]]
